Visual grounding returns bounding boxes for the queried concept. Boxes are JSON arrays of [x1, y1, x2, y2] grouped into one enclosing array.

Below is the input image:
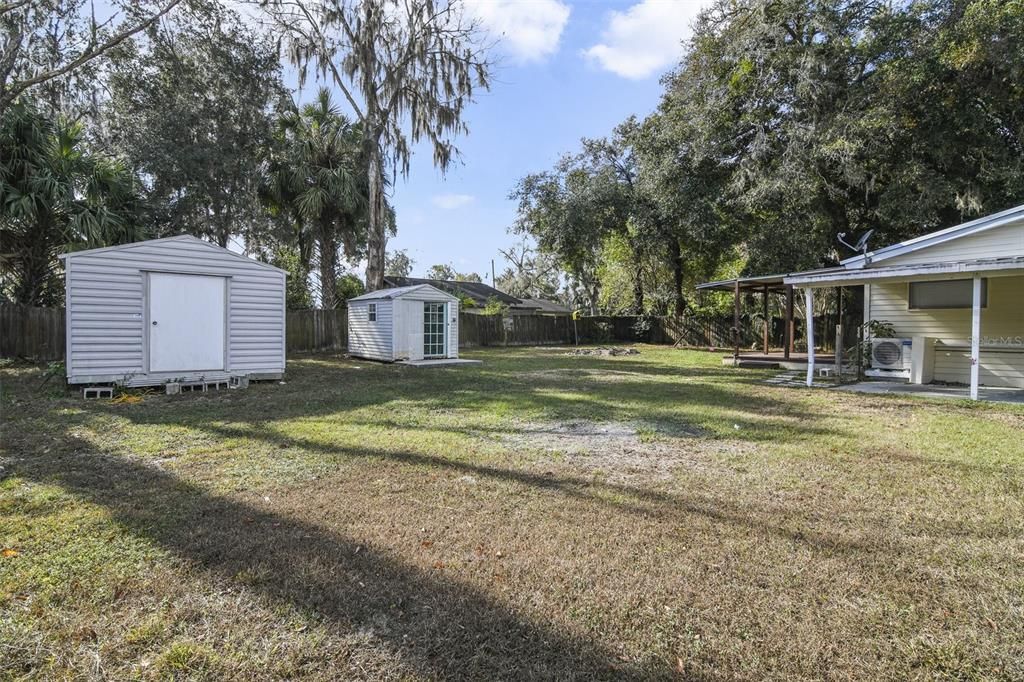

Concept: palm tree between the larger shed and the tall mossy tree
[[261, 89, 367, 308]]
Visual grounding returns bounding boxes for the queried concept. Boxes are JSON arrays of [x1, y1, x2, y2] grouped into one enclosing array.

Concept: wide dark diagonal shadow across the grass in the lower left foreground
[[14, 444, 672, 679]]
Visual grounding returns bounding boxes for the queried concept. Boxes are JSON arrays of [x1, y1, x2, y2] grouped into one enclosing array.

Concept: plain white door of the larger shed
[[150, 272, 226, 372]]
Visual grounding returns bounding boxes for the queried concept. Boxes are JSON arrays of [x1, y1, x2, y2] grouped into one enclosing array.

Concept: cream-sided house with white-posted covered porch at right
[[784, 201, 1024, 398]]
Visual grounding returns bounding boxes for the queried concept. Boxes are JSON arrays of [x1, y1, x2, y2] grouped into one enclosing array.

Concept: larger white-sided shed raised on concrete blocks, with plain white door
[[60, 236, 286, 386]]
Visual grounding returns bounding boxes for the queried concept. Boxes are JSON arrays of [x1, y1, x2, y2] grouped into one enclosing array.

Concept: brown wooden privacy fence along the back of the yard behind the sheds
[[0, 303, 760, 360]]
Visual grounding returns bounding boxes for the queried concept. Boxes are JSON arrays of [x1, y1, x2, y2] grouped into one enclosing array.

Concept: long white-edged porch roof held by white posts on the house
[[784, 256, 1024, 288]]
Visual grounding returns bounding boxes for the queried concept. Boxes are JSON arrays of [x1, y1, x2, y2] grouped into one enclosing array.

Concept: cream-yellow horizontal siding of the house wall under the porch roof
[[867, 276, 1024, 388]]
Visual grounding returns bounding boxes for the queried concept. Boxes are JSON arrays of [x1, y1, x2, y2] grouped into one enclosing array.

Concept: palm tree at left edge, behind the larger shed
[[0, 101, 142, 305]]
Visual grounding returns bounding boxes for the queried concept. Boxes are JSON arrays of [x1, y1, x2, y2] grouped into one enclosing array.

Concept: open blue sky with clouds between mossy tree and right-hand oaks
[[350, 0, 701, 281]]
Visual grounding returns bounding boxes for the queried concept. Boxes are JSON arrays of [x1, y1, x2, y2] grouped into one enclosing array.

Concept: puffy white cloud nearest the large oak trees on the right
[[584, 0, 707, 80]]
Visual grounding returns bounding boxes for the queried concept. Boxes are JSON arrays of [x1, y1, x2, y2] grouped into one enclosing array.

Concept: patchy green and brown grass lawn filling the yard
[[0, 346, 1024, 680]]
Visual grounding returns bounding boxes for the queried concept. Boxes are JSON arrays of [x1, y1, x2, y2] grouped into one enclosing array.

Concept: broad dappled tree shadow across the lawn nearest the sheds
[[86, 358, 849, 454]]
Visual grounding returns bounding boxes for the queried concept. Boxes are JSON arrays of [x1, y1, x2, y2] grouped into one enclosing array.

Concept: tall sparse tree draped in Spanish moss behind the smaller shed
[[260, 0, 493, 291]]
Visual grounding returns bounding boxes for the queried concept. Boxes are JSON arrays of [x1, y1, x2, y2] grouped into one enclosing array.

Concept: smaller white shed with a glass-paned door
[[348, 285, 459, 363]]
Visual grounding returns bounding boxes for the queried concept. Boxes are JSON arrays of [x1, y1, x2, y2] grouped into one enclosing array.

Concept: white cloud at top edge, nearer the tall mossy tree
[[466, 0, 569, 63]]
